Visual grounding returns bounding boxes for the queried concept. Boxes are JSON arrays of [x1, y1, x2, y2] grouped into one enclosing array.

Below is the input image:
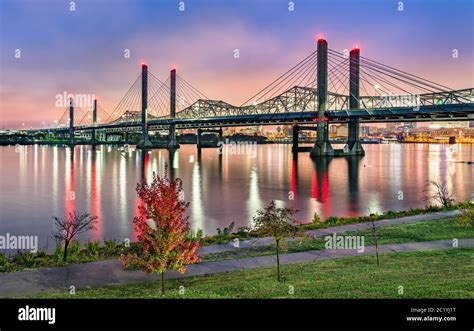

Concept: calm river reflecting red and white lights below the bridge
[[0, 144, 474, 249]]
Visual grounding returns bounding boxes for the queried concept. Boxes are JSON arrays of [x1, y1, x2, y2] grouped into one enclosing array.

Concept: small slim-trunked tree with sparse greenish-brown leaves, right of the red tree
[[253, 200, 298, 281]]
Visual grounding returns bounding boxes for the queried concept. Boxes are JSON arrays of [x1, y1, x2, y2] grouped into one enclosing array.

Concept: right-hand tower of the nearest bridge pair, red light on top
[[344, 47, 365, 156]]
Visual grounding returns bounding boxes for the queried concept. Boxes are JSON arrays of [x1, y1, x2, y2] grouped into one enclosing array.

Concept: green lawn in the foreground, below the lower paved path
[[32, 248, 474, 299]]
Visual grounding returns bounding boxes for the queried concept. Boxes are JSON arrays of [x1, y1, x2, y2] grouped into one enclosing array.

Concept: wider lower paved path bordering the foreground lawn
[[0, 238, 474, 297]]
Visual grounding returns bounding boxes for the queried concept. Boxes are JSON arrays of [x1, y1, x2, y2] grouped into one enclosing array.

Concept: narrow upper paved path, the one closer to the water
[[199, 210, 461, 255]]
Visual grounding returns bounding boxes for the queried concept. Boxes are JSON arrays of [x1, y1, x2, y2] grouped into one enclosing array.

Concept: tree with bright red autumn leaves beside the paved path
[[120, 173, 199, 294]]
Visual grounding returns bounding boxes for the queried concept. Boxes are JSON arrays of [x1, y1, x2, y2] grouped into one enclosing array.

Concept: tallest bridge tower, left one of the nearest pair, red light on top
[[310, 37, 334, 157]]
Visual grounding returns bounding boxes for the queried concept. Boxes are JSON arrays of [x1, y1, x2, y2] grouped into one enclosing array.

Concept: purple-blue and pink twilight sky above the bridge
[[0, 0, 474, 129]]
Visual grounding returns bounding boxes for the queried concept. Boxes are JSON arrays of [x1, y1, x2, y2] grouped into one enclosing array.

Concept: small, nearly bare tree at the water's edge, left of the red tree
[[53, 211, 97, 262]]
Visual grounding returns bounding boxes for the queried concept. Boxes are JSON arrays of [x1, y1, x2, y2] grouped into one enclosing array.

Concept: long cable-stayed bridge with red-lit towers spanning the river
[[5, 38, 474, 157]]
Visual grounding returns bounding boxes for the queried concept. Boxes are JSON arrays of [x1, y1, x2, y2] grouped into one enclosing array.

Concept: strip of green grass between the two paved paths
[[203, 217, 474, 261]]
